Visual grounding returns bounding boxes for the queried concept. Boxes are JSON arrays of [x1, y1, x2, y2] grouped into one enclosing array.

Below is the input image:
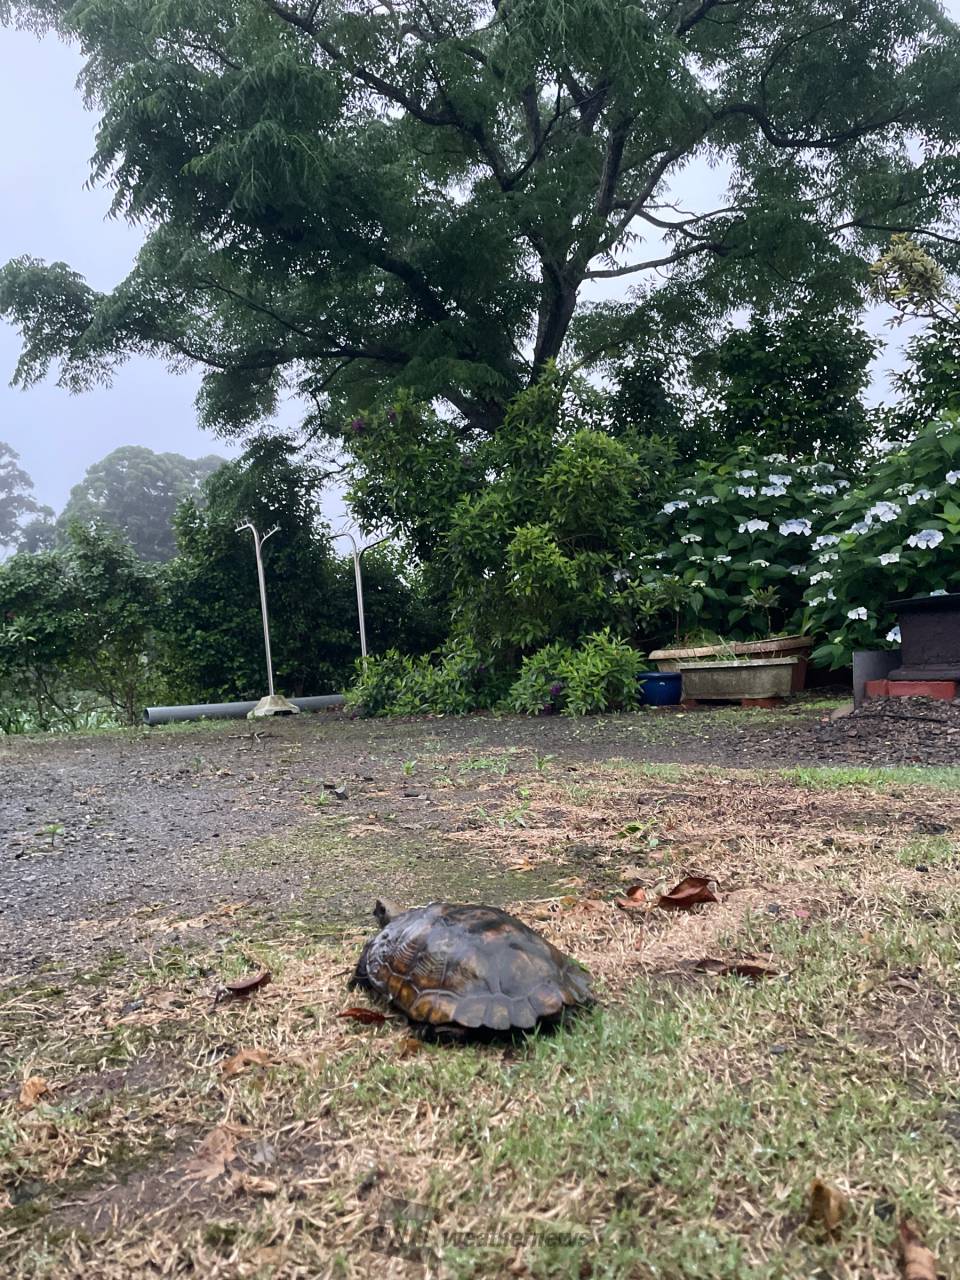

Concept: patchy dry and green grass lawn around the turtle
[[0, 753, 960, 1280]]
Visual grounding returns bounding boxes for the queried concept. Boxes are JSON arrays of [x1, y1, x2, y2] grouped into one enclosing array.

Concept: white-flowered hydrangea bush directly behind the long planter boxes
[[625, 447, 850, 640]]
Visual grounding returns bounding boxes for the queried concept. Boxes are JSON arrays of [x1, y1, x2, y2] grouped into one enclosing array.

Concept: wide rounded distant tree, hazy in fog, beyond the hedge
[[58, 444, 224, 561]]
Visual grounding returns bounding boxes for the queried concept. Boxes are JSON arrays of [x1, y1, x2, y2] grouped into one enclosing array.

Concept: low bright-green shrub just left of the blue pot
[[507, 630, 644, 716]]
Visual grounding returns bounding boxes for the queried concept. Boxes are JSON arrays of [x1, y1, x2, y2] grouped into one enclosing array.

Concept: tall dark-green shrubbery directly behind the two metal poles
[[160, 436, 439, 701]]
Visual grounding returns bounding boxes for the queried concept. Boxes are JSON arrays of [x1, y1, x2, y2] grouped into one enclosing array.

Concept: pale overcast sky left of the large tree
[[0, 10, 960, 520]]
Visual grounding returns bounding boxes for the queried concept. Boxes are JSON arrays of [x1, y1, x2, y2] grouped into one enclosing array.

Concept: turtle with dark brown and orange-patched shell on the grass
[[351, 901, 594, 1036]]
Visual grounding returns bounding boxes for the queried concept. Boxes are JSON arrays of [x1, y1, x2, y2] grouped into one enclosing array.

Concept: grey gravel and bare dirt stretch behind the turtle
[[0, 701, 960, 974]]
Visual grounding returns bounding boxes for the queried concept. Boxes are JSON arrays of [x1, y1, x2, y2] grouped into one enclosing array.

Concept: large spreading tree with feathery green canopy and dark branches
[[0, 0, 960, 450]]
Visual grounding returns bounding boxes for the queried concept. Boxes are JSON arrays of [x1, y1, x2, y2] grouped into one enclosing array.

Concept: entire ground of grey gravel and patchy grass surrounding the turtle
[[0, 700, 960, 1280]]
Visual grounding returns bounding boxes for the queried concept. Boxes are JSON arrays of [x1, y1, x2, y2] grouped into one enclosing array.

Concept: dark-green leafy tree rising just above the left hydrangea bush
[[692, 309, 877, 467]]
